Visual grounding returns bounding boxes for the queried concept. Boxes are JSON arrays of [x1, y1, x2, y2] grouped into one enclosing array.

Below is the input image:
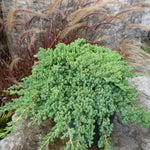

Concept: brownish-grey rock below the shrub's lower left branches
[[0, 116, 66, 150]]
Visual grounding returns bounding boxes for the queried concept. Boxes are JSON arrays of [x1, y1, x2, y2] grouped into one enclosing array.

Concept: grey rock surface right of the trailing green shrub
[[112, 75, 150, 150]]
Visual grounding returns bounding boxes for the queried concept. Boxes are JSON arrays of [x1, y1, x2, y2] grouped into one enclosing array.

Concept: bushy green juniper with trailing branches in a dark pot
[[0, 39, 150, 150]]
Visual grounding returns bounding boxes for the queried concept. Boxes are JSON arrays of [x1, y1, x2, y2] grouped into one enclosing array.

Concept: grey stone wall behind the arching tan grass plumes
[[2, 0, 150, 53]]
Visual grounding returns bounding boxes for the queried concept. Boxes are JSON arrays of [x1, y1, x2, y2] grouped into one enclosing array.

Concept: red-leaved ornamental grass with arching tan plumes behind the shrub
[[0, 0, 150, 101]]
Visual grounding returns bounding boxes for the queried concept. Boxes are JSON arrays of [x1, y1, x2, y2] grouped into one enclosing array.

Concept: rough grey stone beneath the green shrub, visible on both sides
[[0, 74, 150, 150]]
